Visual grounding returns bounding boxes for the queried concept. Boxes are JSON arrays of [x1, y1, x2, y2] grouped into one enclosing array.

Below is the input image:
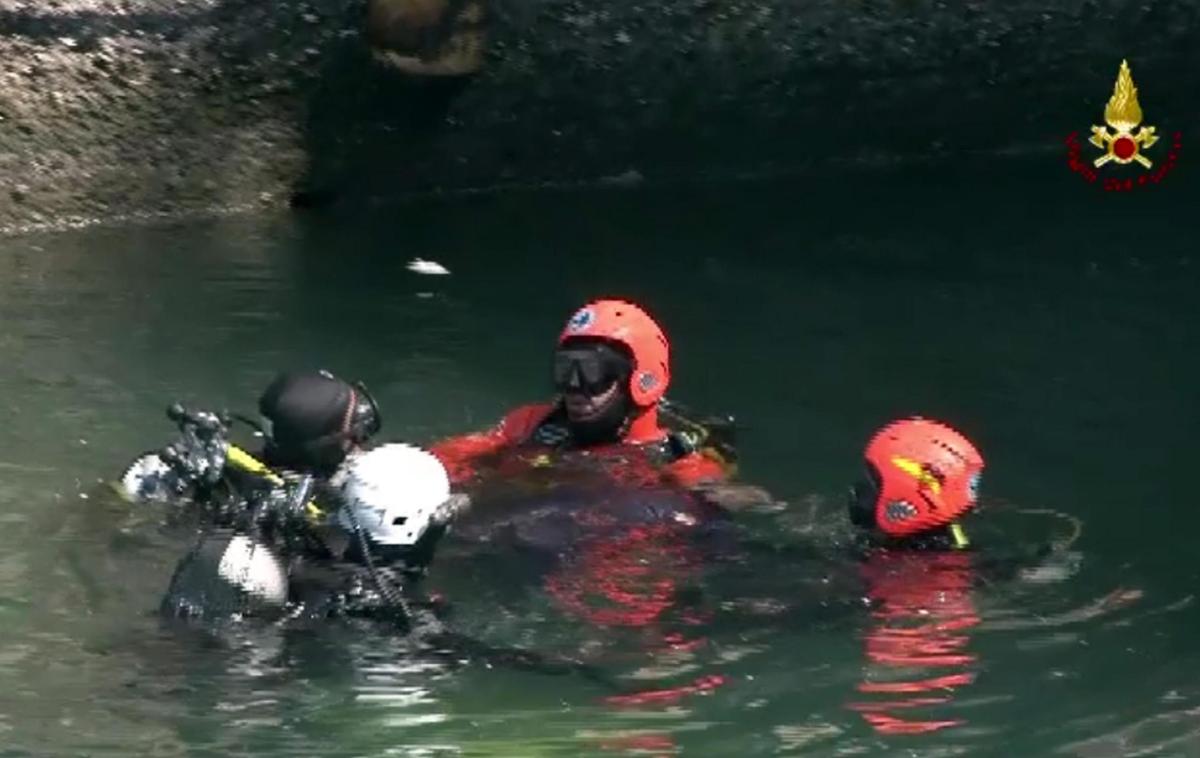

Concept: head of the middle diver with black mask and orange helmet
[[553, 300, 671, 444]]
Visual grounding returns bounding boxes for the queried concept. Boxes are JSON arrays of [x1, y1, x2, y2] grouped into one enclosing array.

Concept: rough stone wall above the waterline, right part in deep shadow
[[0, 0, 1200, 231]]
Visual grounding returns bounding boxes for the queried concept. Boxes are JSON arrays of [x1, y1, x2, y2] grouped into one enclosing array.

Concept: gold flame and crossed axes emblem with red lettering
[[1067, 60, 1181, 192]]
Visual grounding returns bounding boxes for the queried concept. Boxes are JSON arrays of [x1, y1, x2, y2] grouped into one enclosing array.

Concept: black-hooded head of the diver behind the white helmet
[[258, 371, 383, 475]]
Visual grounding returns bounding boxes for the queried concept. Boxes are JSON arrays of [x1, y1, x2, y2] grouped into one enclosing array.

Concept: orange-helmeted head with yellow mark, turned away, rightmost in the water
[[850, 417, 984, 547]]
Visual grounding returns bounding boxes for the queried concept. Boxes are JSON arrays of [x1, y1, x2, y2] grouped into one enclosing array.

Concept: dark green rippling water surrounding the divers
[[0, 167, 1200, 756]]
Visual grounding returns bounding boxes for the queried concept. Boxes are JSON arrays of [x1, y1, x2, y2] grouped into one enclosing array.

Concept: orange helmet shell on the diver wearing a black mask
[[558, 300, 671, 408]]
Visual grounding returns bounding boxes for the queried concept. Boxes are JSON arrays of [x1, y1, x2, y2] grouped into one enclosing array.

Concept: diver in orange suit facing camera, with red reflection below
[[431, 300, 760, 705]]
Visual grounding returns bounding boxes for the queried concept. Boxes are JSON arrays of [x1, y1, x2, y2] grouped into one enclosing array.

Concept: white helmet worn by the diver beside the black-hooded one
[[330, 443, 452, 547]]
